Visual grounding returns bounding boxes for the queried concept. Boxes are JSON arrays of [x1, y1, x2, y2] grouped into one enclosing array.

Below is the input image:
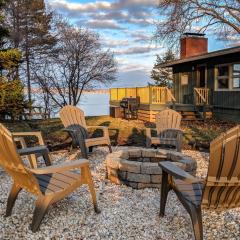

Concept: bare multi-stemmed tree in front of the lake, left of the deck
[[35, 20, 116, 107]]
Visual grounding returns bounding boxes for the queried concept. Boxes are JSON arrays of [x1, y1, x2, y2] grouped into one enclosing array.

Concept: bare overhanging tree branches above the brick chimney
[[155, 0, 240, 45]]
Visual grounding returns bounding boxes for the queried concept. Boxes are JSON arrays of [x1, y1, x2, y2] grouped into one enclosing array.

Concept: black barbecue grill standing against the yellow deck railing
[[120, 97, 140, 119]]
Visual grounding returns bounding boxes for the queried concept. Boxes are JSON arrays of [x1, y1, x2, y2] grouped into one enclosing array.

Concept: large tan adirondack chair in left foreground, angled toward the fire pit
[[0, 124, 99, 232]]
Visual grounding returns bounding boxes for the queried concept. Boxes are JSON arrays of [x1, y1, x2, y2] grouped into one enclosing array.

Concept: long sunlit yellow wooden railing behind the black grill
[[110, 86, 176, 104]]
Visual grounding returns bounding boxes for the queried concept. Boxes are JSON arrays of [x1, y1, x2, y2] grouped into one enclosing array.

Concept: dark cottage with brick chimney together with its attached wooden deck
[[110, 33, 240, 122]]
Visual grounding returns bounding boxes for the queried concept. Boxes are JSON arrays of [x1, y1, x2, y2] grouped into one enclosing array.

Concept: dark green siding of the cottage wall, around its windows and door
[[173, 53, 240, 121]]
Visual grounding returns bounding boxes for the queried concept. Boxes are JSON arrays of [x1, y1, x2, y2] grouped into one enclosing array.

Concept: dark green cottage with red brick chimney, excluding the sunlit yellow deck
[[159, 33, 240, 121]]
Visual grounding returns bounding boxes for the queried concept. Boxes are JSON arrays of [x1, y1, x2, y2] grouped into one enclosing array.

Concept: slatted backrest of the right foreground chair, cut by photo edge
[[202, 125, 240, 208]]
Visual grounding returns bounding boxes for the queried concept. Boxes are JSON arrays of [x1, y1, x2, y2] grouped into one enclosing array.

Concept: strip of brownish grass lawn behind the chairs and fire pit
[[2, 116, 236, 150]]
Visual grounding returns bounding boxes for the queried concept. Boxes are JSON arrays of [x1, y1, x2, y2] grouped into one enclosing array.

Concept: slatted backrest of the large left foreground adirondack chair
[[0, 124, 40, 194]]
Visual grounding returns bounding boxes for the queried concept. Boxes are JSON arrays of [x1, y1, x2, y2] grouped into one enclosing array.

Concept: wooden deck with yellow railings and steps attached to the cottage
[[110, 86, 212, 122]]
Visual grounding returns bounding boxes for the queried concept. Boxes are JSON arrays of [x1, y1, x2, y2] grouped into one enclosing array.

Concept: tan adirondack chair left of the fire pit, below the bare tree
[[59, 105, 112, 158]]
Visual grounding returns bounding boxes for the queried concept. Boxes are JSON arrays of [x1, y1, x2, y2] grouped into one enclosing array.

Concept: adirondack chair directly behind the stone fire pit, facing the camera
[[146, 109, 182, 152]]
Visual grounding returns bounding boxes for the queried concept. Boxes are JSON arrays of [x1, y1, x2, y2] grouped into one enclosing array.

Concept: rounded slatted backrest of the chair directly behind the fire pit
[[156, 109, 182, 134]]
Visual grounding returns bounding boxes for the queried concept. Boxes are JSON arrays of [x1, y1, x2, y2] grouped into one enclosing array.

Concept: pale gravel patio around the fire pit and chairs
[[0, 147, 240, 240]]
